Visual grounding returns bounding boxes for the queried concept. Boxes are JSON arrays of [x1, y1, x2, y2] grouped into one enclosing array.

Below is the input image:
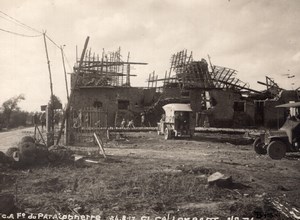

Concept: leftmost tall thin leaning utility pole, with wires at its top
[[43, 32, 54, 144]]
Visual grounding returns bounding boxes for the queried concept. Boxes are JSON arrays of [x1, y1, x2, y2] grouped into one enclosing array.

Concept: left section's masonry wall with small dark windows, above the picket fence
[[72, 87, 155, 126]]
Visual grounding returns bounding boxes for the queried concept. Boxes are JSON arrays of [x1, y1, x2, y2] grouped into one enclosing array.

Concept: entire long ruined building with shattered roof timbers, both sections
[[67, 48, 300, 142]]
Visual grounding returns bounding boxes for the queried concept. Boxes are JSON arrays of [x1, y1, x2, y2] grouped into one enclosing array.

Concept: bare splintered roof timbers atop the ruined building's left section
[[74, 48, 147, 88]]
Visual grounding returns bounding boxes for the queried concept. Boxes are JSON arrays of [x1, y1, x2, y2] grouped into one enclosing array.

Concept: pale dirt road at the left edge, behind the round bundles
[[0, 127, 34, 152]]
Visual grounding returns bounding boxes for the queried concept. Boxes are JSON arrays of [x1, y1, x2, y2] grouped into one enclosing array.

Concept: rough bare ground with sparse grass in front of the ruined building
[[0, 132, 300, 219]]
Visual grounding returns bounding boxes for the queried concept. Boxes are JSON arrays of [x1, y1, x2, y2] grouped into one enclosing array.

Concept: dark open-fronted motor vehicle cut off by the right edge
[[253, 102, 300, 160]]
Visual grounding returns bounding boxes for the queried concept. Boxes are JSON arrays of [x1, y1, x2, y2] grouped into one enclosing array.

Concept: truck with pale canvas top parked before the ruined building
[[158, 103, 195, 140]]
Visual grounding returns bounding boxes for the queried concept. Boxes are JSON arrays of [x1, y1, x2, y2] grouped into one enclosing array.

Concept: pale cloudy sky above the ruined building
[[0, 0, 300, 111]]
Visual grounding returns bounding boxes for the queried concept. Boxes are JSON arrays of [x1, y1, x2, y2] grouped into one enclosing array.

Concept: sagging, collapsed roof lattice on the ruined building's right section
[[148, 50, 259, 93]]
